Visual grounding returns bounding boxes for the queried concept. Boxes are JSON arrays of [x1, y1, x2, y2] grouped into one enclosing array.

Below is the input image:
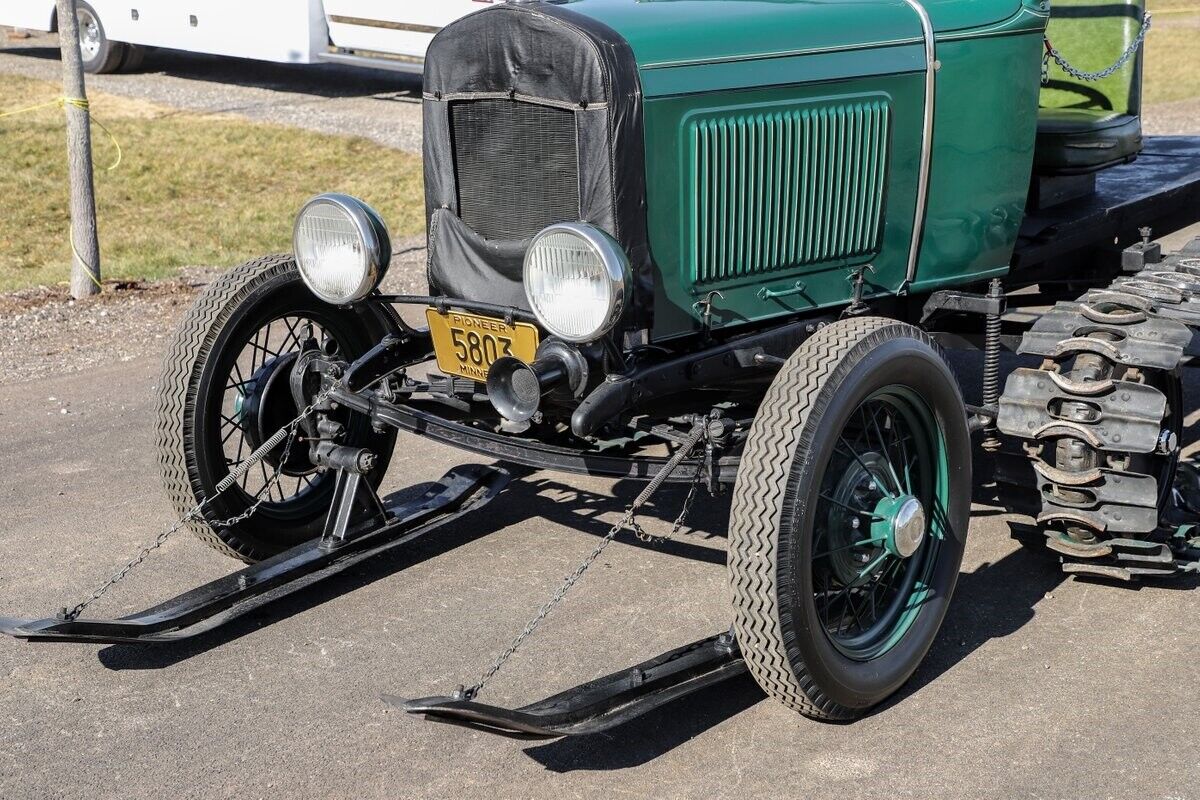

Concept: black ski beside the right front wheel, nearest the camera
[[398, 633, 746, 739]]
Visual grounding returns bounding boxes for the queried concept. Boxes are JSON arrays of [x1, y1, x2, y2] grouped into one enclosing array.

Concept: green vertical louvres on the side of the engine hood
[[689, 100, 890, 283]]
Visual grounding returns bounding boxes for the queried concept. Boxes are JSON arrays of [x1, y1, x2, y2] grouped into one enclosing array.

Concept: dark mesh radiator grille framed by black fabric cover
[[450, 100, 580, 240]]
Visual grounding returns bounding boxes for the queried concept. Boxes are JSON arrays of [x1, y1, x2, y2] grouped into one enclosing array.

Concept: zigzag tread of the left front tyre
[[155, 254, 296, 563]]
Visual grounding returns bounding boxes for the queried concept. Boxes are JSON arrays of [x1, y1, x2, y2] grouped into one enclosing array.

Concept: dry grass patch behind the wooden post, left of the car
[[0, 76, 425, 291]]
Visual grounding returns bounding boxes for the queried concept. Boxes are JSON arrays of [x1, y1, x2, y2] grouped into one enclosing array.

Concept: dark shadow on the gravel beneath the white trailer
[[0, 47, 421, 103]]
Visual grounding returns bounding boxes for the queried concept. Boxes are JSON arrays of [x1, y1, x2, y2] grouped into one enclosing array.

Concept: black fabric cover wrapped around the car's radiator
[[424, 2, 654, 329]]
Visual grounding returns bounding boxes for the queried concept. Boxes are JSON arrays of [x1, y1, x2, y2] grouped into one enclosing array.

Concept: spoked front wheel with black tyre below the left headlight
[[156, 255, 396, 561]]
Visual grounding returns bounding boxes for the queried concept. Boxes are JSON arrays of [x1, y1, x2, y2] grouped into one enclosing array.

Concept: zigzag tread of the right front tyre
[[728, 317, 912, 720]]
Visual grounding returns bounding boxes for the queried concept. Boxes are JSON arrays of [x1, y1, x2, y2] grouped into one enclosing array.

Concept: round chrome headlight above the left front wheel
[[292, 194, 391, 306]]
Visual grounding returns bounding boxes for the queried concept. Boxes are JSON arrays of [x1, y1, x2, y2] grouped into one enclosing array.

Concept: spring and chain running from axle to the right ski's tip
[[455, 417, 709, 700]]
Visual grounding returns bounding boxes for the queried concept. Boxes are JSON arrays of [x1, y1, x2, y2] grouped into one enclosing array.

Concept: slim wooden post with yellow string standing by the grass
[[58, 0, 100, 300]]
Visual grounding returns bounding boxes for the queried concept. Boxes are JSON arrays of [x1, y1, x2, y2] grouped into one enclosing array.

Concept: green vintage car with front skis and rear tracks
[[6, 0, 1200, 736]]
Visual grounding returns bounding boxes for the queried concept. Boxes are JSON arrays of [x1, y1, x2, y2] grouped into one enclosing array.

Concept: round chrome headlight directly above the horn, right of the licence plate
[[524, 222, 631, 342]]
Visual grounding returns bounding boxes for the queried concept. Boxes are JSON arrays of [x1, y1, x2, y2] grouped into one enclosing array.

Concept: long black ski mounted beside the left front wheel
[[0, 464, 512, 644]]
